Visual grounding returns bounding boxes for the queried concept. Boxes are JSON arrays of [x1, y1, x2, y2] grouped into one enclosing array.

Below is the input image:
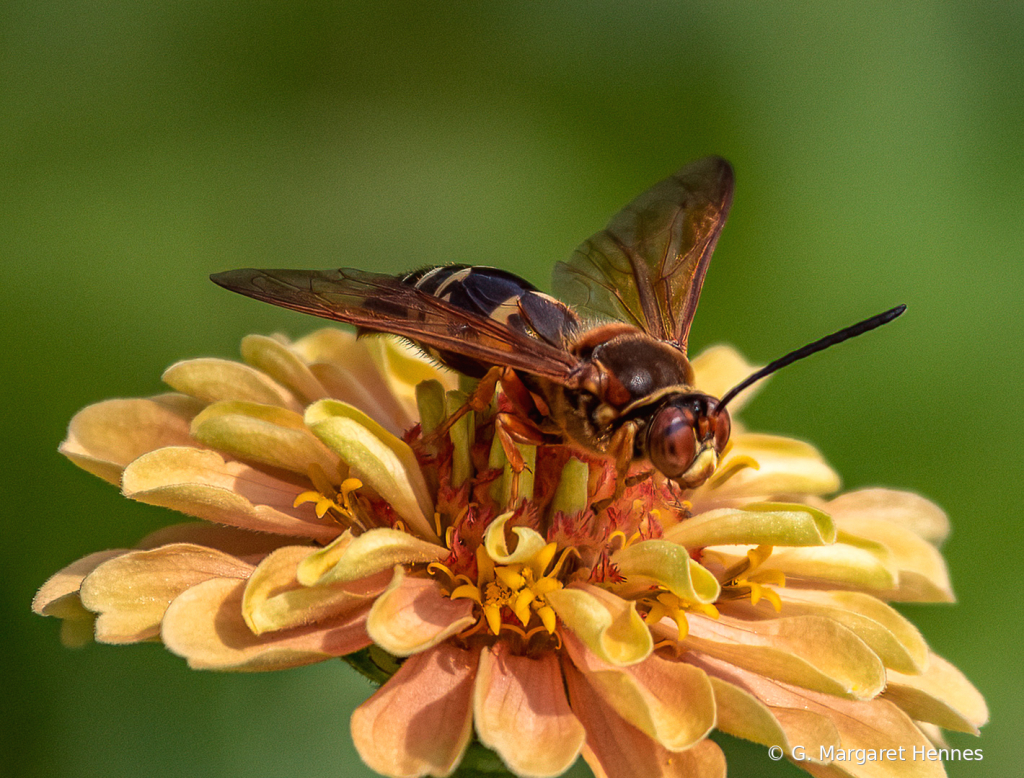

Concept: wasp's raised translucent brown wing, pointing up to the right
[[554, 157, 733, 351]]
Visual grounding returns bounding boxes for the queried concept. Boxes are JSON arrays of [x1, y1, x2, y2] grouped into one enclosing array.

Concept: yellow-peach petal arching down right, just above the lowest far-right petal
[[778, 589, 928, 673]]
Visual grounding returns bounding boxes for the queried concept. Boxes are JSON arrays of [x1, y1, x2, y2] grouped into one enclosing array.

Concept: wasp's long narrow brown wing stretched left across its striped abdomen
[[210, 268, 578, 383]]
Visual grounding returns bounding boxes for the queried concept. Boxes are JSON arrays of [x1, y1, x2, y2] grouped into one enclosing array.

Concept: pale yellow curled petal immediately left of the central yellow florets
[[299, 527, 447, 586]]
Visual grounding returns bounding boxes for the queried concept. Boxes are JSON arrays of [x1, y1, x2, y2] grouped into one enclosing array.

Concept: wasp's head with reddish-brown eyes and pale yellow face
[[647, 394, 732, 488]]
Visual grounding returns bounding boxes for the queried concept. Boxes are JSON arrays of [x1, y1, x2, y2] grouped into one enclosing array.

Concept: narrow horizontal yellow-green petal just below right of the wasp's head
[[665, 503, 836, 549]]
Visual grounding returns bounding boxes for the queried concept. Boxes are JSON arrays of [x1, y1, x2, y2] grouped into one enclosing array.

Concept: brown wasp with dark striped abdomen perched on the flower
[[211, 157, 905, 489]]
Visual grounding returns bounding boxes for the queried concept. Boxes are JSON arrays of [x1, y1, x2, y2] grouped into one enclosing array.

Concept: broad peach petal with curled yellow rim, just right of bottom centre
[[563, 633, 715, 751]]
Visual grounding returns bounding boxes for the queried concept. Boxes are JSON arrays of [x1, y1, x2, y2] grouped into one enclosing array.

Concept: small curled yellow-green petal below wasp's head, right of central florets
[[612, 541, 722, 603]]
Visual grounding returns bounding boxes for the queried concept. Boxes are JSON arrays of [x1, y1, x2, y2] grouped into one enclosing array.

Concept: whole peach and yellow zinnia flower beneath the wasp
[[34, 330, 987, 778]]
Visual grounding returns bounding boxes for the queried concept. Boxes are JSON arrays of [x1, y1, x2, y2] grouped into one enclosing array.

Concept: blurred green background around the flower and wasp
[[0, 0, 1024, 778]]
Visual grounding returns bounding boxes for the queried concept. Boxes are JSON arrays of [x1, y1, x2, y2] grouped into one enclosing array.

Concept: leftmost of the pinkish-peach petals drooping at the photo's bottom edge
[[351, 644, 478, 778]]
